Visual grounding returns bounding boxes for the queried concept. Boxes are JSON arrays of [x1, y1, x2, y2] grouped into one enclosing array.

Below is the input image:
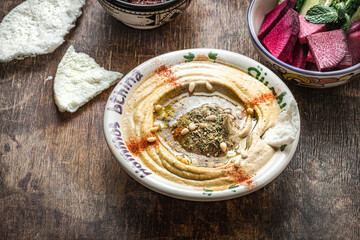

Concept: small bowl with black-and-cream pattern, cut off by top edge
[[98, 0, 191, 29]]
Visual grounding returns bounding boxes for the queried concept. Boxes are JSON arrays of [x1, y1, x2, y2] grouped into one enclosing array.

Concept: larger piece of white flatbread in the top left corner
[[0, 0, 85, 62]]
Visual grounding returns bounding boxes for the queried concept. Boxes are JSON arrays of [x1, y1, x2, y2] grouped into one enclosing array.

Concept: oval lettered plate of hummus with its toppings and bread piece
[[104, 49, 300, 201]]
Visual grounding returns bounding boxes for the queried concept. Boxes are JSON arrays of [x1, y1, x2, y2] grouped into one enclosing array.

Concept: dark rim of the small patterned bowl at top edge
[[104, 0, 182, 11]]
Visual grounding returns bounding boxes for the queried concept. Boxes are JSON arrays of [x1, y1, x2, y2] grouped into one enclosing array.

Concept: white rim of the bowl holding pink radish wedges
[[247, 0, 360, 77]]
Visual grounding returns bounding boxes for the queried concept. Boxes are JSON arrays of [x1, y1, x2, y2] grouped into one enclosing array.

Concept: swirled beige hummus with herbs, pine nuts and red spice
[[122, 61, 280, 188]]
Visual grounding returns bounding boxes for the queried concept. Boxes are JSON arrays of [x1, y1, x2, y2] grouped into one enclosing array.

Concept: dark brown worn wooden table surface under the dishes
[[0, 0, 360, 239]]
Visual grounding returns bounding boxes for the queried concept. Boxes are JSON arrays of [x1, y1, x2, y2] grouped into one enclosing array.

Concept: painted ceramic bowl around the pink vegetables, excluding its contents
[[247, 0, 360, 88]]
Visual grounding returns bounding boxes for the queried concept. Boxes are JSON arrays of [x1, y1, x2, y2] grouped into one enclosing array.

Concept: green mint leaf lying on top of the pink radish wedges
[[305, 4, 339, 23]]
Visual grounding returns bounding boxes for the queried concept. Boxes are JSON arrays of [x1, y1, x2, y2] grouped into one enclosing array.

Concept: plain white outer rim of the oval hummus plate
[[103, 48, 301, 202]]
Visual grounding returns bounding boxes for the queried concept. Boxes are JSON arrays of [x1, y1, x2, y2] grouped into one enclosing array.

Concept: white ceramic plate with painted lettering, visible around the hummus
[[104, 49, 300, 201]]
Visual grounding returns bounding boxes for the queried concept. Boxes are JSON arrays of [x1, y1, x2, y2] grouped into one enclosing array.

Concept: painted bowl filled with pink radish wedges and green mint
[[247, 0, 360, 88]]
